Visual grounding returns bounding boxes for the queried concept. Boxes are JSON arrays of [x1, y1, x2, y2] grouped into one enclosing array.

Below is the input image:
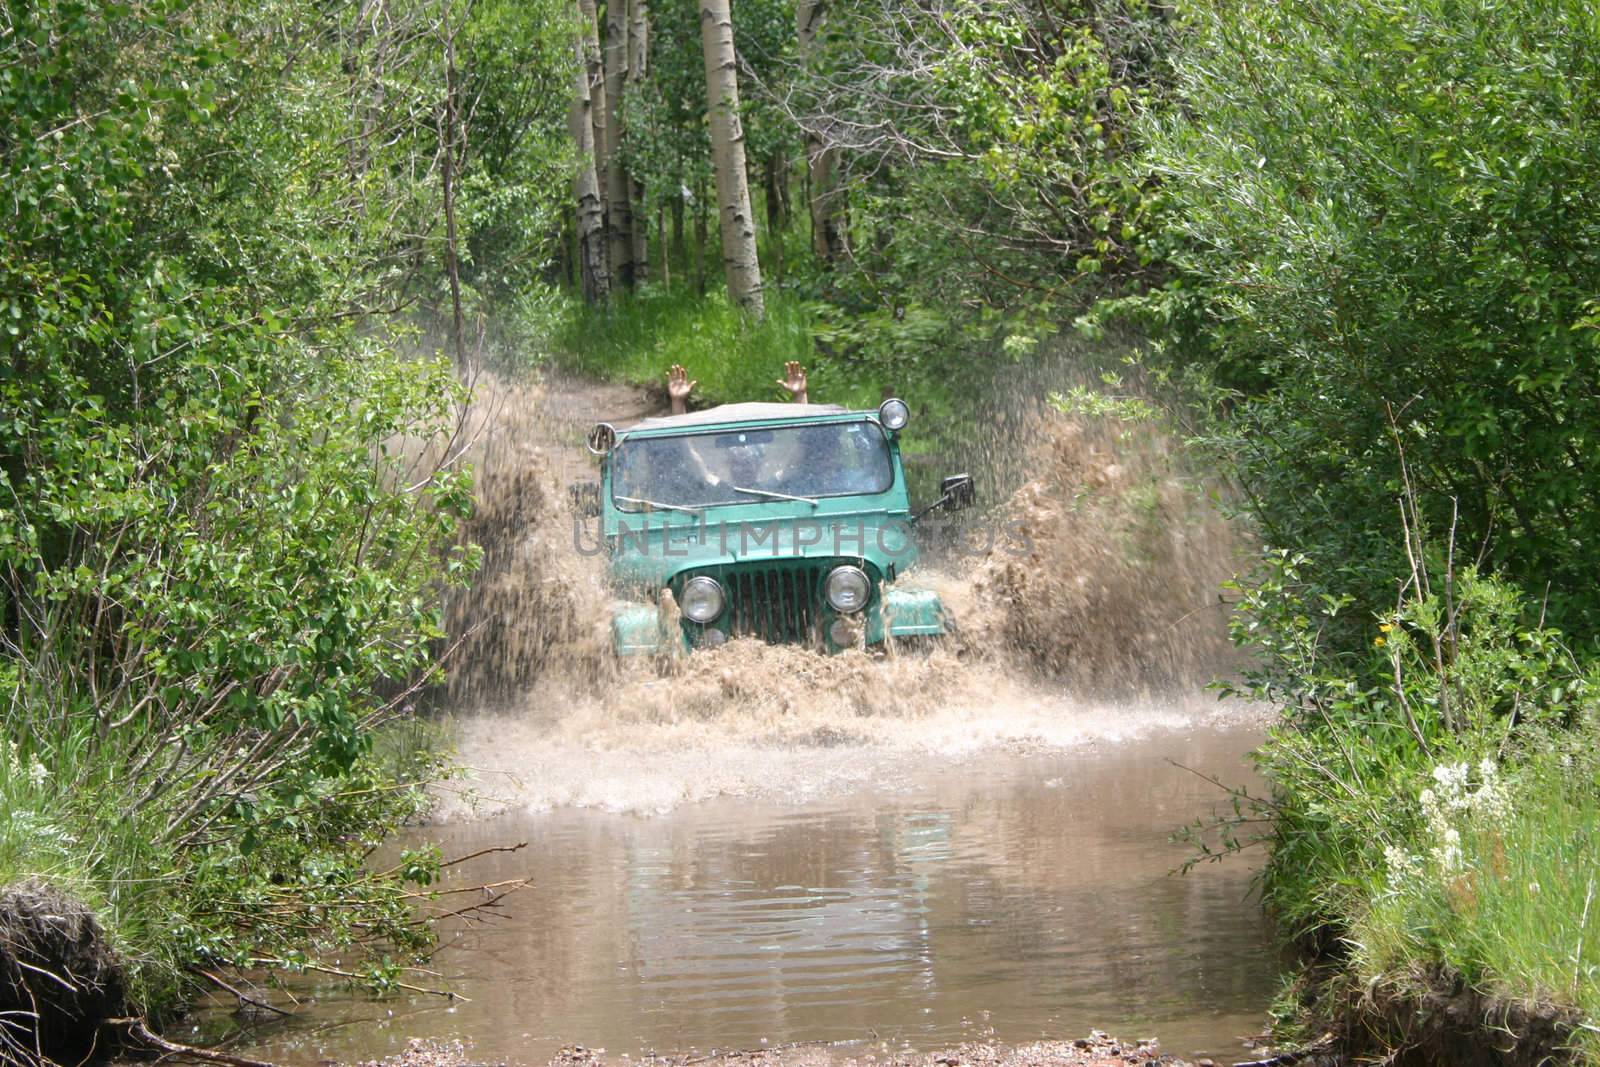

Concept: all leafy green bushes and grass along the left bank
[[0, 0, 553, 1011]]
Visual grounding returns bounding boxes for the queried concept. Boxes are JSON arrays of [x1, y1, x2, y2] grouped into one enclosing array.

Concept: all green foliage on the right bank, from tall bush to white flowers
[[1120, 0, 1600, 1054]]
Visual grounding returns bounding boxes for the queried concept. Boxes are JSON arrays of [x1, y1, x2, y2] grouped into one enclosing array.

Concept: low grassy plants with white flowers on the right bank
[[1209, 552, 1600, 1021]]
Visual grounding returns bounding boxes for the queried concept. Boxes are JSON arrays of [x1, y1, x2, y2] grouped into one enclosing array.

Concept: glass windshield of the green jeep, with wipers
[[611, 419, 894, 512]]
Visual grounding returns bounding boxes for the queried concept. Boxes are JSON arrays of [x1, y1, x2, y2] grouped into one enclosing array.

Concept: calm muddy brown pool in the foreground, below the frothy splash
[[196, 709, 1278, 1064]]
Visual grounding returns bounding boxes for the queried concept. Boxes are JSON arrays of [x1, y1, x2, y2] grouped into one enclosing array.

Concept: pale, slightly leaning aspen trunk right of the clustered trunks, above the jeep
[[701, 0, 766, 320]]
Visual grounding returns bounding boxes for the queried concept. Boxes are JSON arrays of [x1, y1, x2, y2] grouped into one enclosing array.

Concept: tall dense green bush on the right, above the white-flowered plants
[[1142, 0, 1600, 641]]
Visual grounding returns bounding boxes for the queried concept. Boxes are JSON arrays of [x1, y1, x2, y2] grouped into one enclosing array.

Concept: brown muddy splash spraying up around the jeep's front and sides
[[437, 363, 1248, 819]]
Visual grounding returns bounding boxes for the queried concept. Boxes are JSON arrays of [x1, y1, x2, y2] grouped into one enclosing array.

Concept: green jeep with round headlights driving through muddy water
[[573, 400, 973, 656]]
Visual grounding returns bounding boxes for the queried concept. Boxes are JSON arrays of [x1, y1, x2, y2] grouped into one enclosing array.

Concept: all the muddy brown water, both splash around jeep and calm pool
[[193, 369, 1280, 1065]]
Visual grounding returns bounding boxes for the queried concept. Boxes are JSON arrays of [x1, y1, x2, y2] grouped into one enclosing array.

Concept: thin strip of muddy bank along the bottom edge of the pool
[[358, 1030, 1211, 1067]]
